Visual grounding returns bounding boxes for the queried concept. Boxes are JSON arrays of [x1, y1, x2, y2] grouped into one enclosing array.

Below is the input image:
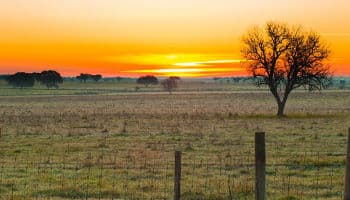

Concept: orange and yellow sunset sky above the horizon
[[0, 0, 350, 77]]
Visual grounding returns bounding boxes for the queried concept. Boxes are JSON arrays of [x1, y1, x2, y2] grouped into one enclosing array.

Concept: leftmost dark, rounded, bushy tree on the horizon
[[6, 72, 35, 88]]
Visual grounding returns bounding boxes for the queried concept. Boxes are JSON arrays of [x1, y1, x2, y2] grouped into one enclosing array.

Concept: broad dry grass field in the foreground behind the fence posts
[[0, 91, 350, 199]]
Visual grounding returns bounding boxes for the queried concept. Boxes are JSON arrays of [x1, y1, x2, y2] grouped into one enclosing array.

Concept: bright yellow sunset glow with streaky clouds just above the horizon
[[113, 54, 242, 77]]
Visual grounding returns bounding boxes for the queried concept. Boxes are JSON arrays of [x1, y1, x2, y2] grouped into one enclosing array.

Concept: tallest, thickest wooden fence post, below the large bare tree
[[255, 132, 266, 200]]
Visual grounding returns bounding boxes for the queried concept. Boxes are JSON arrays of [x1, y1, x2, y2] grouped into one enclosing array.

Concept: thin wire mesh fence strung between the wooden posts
[[0, 131, 347, 199]]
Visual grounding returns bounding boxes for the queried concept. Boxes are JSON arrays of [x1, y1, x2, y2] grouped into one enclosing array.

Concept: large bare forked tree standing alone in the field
[[242, 22, 331, 116]]
